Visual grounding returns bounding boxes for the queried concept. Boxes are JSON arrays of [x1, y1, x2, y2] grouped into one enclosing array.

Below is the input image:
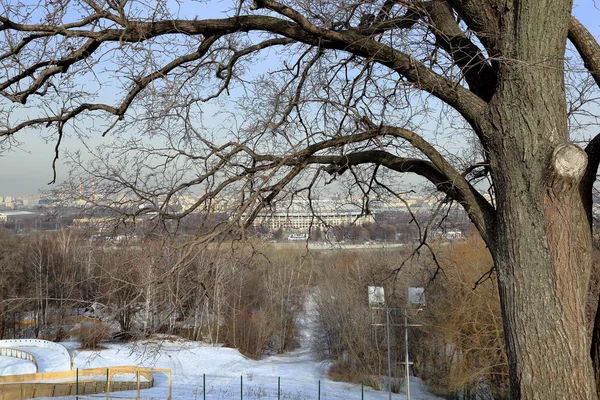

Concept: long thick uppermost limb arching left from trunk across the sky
[[0, 1, 486, 135]]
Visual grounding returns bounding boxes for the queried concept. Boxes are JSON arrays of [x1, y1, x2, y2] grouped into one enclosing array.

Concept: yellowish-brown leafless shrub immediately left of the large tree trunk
[[413, 236, 508, 398]]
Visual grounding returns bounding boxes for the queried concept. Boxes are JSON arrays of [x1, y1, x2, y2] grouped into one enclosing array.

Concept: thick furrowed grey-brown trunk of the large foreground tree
[[489, 0, 596, 400]]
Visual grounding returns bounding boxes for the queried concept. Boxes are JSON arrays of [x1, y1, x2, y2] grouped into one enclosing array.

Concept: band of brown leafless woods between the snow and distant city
[[0, 230, 552, 399]]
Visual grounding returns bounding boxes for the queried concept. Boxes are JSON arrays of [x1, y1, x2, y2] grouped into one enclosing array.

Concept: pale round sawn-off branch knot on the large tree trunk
[[550, 143, 587, 191]]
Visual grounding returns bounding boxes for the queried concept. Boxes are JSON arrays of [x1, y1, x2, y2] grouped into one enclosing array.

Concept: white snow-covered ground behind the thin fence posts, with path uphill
[[0, 296, 437, 400]]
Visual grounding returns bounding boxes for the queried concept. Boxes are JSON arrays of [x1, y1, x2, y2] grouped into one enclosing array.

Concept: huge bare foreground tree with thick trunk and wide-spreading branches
[[0, 0, 600, 399]]
